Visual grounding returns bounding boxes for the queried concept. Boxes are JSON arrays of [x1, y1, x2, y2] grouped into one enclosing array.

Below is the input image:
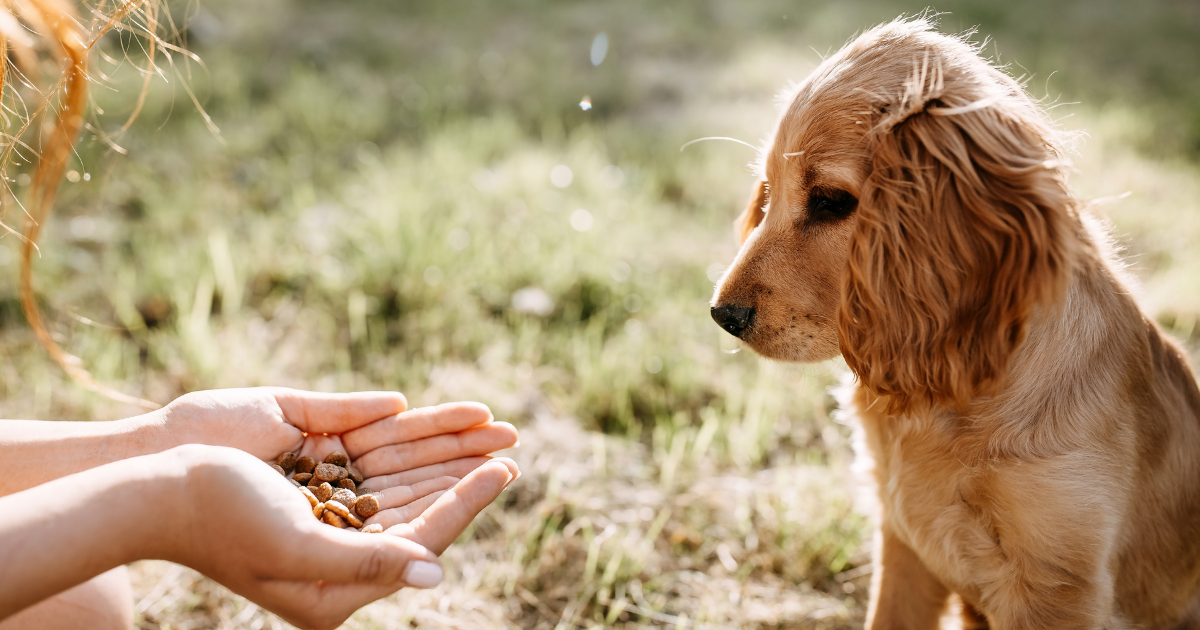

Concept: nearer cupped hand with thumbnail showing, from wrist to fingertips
[[161, 445, 516, 629]]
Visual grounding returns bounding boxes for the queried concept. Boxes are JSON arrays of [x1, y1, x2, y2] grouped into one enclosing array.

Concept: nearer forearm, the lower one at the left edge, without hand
[[0, 454, 185, 619]]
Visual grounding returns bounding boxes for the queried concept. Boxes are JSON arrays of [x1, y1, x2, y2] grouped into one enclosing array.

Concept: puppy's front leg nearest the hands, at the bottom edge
[[866, 524, 950, 630]]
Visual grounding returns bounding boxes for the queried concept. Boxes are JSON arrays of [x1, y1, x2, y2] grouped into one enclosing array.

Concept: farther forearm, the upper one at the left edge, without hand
[[0, 413, 176, 497]]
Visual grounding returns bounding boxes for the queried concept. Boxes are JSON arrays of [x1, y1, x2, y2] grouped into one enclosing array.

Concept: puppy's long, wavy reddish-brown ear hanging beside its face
[[838, 88, 1080, 413]]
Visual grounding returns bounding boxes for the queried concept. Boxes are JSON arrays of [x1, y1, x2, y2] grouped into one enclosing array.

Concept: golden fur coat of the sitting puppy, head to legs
[[713, 19, 1200, 630]]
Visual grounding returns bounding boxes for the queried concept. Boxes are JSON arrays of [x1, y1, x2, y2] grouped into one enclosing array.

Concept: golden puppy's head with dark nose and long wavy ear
[[713, 19, 1080, 413]]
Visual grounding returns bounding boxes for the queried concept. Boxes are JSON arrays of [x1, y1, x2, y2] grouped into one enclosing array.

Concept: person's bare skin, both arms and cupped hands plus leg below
[[0, 388, 520, 630]]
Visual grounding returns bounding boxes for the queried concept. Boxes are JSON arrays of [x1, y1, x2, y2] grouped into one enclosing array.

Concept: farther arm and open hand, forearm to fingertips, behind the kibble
[[0, 388, 517, 496]]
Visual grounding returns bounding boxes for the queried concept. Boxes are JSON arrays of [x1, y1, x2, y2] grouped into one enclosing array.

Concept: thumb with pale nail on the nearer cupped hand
[[293, 526, 443, 588]]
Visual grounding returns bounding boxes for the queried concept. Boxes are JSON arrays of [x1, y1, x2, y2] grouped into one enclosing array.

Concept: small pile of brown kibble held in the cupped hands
[[271, 451, 383, 534]]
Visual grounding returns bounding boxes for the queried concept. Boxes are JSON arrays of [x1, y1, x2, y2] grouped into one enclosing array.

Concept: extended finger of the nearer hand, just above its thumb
[[386, 461, 516, 554]]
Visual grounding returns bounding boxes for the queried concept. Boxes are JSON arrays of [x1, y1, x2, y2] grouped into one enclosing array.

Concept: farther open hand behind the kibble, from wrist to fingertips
[[149, 388, 516, 470]]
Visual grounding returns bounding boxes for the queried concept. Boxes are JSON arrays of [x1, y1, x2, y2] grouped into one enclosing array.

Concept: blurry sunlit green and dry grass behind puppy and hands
[[0, 0, 1200, 629]]
